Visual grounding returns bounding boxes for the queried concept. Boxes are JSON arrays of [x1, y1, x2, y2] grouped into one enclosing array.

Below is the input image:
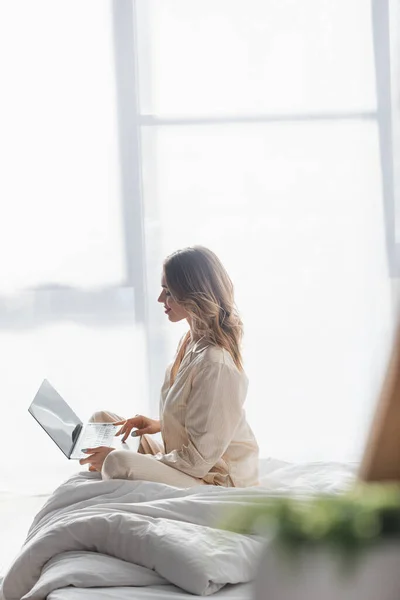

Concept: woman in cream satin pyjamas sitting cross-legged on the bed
[[80, 246, 258, 487]]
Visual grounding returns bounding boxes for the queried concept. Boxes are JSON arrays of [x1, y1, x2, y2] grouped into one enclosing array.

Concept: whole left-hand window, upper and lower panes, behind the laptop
[[0, 0, 148, 492]]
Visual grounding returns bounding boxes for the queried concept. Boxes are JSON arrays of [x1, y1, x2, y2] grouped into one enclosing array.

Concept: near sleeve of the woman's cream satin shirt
[[156, 363, 247, 478]]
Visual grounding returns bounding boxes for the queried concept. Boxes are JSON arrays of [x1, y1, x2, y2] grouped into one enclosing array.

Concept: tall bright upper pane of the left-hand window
[[0, 0, 125, 290]]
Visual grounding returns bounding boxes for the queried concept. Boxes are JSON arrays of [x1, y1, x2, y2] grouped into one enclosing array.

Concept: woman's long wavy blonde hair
[[164, 246, 243, 384]]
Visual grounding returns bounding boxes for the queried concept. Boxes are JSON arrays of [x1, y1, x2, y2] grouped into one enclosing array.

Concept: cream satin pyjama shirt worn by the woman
[[144, 340, 258, 487]]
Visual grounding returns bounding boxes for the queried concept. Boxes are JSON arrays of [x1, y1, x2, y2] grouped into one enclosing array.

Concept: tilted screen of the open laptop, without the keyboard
[[29, 379, 82, 458]]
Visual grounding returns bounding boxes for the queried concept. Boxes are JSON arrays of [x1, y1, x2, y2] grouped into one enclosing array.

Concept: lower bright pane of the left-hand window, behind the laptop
[[0, 290, 148, 494]]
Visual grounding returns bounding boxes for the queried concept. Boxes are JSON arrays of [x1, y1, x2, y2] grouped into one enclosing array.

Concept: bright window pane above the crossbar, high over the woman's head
[[137, 0, 376, 116]]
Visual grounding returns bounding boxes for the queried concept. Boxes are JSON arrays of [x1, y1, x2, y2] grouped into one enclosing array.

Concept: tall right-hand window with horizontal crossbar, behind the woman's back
[[134, 0, 394, 460]]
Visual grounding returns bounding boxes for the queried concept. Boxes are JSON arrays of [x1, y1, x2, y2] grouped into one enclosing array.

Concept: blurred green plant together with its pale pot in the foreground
[[228, 484, 400, 600]]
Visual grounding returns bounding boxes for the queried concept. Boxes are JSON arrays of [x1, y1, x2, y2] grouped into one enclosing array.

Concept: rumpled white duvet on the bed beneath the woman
[[3, 462, 354, 600]]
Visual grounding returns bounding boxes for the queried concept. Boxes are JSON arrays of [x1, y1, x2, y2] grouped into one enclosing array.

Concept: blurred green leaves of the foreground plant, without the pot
[[224, 484, 400, 555]]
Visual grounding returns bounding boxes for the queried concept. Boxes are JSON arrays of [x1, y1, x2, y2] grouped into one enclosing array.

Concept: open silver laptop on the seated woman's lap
[[28, 379, 119, 460]]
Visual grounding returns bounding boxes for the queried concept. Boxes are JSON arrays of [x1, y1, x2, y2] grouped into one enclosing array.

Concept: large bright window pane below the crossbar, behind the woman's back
[[143, 121, 391, 460]]
